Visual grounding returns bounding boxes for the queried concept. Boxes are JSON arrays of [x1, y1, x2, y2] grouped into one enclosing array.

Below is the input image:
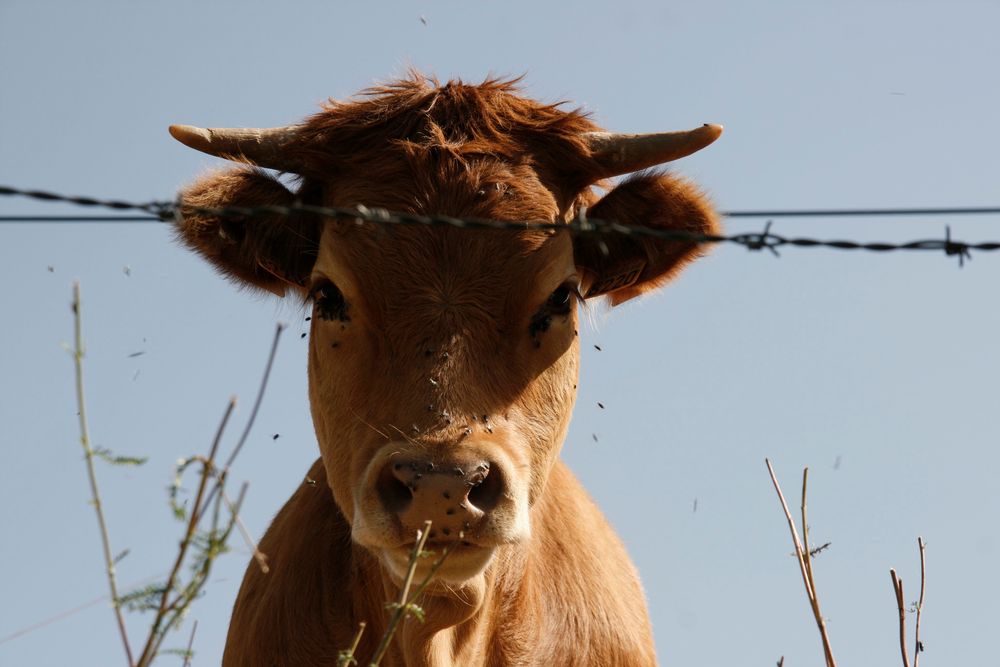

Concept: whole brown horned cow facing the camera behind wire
[[171, 75, 721, 666]]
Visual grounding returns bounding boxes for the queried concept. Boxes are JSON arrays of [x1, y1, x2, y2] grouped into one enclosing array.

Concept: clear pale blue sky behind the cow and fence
[[0, 0, 1000, 667]]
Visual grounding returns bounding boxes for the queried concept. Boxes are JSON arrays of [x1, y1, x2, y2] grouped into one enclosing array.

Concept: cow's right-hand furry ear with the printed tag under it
[[573, 174, 720, 306]]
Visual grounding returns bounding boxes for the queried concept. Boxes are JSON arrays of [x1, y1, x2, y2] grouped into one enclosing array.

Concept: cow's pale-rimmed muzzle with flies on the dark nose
[[353, 443, 530, 582]]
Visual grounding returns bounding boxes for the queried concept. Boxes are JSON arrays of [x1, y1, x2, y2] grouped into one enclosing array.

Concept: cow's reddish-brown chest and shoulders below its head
[[224, 461, 655, 667]]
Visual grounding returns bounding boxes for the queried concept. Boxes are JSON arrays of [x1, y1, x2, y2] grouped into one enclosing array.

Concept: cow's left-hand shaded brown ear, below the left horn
[[177, 167, 320, 296]]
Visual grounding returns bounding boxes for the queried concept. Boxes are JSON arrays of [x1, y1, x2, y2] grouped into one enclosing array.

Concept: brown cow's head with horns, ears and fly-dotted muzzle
[[171, 77, 721, 583]]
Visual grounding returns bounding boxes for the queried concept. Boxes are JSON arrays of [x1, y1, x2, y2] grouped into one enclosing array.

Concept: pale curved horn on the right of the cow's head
[[584, 124, 722, 178]]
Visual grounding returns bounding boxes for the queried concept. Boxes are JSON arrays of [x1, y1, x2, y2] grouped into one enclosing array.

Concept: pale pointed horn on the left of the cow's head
[[170, 125, 301, 173]]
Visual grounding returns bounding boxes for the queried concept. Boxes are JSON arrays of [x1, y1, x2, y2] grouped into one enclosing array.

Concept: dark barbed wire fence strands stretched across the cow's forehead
[[0, 185, 1000, 266]]
